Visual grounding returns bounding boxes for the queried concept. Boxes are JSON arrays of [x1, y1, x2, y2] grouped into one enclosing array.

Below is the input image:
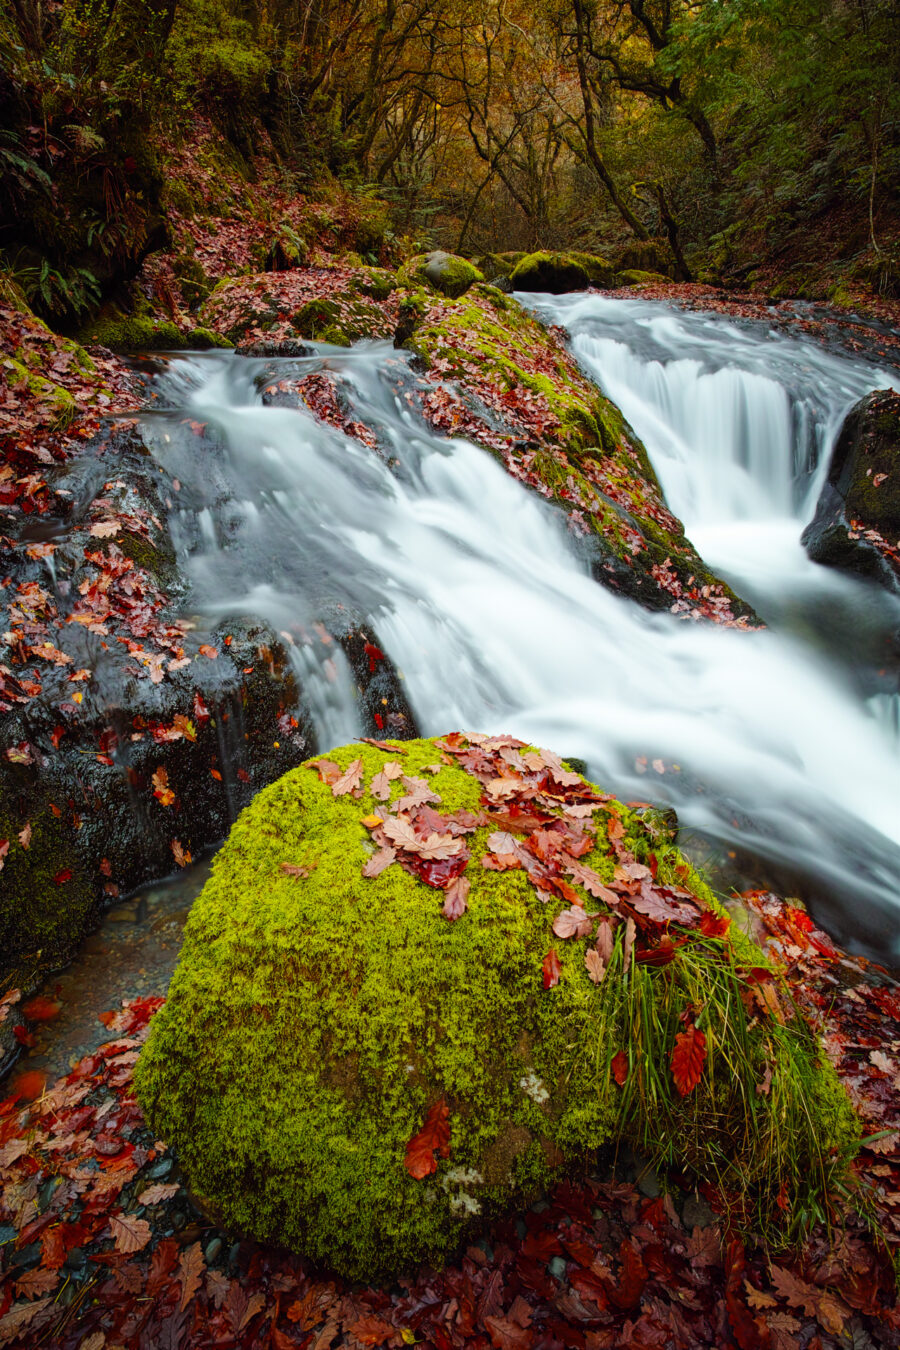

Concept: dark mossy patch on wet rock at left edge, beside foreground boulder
[[0, 770, 96, 984]]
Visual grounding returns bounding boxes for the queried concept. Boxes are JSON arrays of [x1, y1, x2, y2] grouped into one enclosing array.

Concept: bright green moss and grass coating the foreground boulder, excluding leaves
[[135, 741, 857, 1280]]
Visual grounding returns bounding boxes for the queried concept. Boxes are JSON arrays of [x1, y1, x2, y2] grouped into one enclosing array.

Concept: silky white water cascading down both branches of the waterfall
[[144, 297, 900, 953]]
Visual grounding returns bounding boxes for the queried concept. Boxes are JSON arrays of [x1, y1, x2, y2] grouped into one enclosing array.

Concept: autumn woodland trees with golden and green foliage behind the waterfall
[[0, 0, 900, 316]]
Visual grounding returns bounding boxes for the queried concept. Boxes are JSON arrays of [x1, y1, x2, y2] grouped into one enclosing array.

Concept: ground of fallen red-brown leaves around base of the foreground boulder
[[0, 894, 900, 1350]]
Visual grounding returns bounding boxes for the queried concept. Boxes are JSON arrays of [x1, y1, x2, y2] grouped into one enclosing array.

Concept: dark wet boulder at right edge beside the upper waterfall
[[801, 389, 900, 591]]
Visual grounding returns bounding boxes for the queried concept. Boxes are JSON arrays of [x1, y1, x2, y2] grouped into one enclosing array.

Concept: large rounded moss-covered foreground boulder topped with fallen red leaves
[[136, 734, 857, 1280]]
